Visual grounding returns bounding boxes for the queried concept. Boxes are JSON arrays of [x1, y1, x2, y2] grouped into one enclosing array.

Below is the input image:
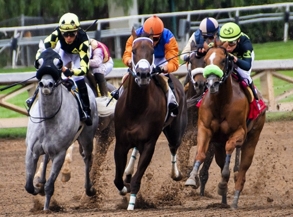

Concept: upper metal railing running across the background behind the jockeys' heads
[[0, 3, 293, 66]]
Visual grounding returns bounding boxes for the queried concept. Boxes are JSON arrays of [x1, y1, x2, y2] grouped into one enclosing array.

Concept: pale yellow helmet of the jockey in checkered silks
[[59, 13, 80, 32]]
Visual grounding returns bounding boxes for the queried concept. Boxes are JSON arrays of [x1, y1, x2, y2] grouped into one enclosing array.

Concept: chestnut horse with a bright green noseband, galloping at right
[[186, 43, 266, 209]]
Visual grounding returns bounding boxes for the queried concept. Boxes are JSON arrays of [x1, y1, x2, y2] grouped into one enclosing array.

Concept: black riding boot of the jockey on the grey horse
[[75, 79, 93, 126]]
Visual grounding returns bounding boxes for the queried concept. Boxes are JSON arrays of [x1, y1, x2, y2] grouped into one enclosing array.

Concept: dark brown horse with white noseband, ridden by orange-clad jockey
[[114, 29, 187, 210]]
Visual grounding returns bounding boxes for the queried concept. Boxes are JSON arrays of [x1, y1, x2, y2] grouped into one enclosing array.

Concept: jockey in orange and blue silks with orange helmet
[[112, 15, 179, 116]]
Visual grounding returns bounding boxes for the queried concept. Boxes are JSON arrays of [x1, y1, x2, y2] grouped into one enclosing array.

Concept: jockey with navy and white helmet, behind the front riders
[[180, 17, 220, 62]]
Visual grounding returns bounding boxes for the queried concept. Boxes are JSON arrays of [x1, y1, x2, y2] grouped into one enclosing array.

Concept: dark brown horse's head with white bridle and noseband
[[132, 28, 154, 86]]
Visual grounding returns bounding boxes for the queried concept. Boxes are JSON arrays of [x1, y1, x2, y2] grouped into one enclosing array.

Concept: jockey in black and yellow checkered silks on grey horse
[[26, 13, 92, 125]]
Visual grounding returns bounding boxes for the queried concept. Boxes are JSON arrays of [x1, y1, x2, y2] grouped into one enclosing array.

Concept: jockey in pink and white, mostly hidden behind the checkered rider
[[89, 39, 114, 96]]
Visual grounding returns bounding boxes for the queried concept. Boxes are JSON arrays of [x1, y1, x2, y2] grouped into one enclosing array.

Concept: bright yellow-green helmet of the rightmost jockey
[[220, 22, 241, 41]]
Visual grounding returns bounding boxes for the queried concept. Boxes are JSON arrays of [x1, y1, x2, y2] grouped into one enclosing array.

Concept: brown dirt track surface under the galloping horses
[[0, 121, 293, 216]]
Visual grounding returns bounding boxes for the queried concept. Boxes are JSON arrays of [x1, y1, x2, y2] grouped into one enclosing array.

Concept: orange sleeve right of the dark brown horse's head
[[164, 37, 179, 73]]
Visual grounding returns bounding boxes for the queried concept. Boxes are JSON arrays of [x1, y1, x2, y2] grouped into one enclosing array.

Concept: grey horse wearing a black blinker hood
[[25, 48, 98, 210]]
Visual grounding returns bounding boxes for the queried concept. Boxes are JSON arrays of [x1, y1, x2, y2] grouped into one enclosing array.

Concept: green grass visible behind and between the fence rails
[[0, 41, 293, 138]]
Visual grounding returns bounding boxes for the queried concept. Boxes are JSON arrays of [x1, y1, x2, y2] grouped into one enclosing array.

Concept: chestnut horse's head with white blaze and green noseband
[[203, 44, 234, 93]]
